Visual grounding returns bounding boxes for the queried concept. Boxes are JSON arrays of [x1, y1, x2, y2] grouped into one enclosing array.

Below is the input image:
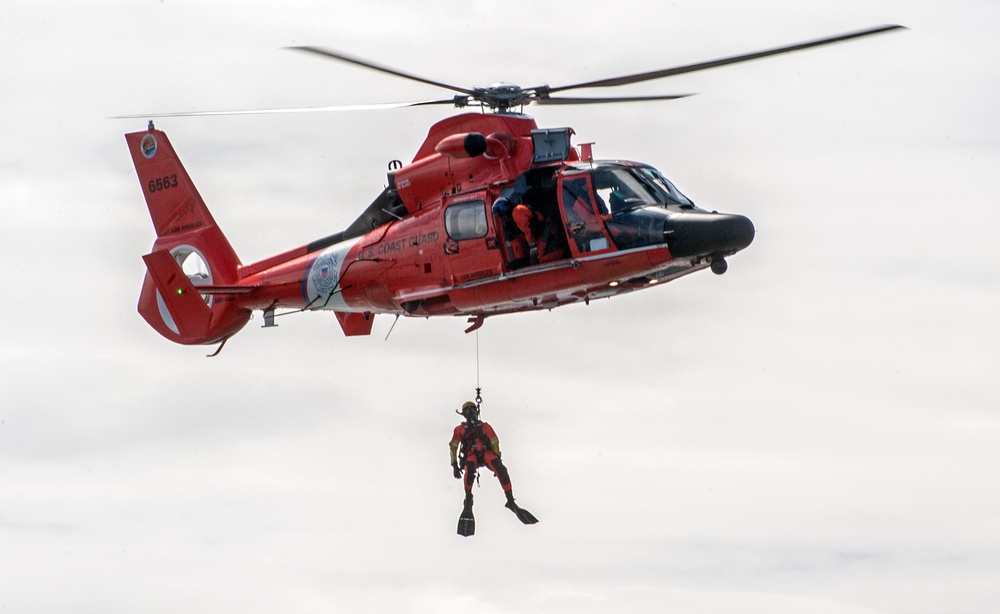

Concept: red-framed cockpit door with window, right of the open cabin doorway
[[558, 173, 615, 258]]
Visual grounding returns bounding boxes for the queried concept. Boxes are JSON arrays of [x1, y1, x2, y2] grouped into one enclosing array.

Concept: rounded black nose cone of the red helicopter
[[664, 211, 755, 258]]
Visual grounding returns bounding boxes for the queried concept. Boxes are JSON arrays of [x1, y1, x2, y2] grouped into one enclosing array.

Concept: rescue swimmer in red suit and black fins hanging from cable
[[449, 401, 538, 537]]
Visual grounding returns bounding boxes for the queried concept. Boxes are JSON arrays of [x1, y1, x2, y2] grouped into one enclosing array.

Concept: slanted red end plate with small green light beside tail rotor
[[142, 250, 212, 337]]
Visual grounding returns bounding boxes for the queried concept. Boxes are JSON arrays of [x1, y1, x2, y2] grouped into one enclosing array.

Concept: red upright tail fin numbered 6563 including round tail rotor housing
[[125, 124, 250, 344]]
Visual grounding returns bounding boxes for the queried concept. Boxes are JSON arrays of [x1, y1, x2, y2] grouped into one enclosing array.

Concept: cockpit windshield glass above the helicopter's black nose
[[594, 166, 694, 215]]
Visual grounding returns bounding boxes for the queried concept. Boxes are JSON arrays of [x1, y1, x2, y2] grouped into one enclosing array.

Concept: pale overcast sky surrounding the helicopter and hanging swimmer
[[0, 0, 1000, 614]]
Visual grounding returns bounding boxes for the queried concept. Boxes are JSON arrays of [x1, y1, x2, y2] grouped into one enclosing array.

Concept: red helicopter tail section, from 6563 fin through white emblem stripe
[[125, 127, 382, 345]]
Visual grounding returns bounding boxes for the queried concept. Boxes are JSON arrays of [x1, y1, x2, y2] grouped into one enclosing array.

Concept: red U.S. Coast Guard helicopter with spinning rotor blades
[[123, 25, 903, 356]]
